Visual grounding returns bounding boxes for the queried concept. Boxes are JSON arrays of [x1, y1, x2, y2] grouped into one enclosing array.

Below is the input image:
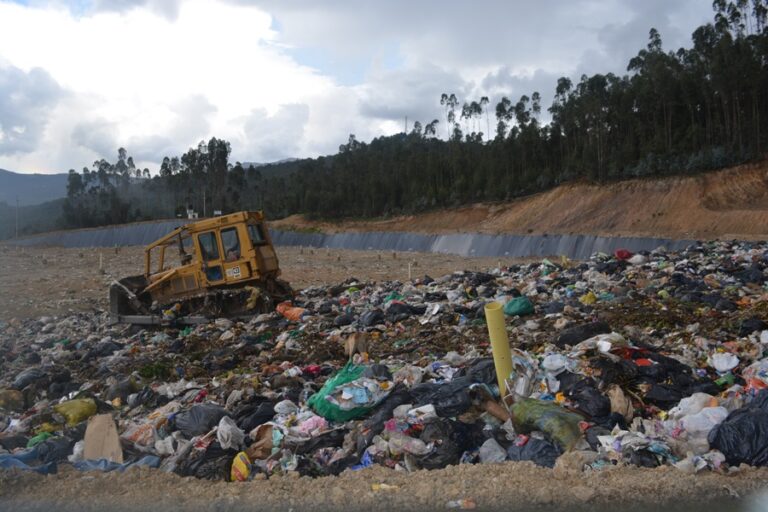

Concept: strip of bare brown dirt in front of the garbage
[[0, 462, 768, 512]]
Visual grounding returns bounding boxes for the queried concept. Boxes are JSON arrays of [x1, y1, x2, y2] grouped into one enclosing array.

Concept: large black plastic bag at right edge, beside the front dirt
[[708, 389, 768, 466]]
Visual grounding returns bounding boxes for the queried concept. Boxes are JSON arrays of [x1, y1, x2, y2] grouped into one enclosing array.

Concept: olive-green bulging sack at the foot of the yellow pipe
[[510, 398, 583, 451]]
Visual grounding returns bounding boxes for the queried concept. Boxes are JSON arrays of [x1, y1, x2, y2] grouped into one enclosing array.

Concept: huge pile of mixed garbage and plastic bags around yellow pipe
[[0, 242, 768, 481]]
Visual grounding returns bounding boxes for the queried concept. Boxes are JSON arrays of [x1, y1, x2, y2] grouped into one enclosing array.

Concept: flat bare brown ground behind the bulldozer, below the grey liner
[[0, 245, 511, 321]]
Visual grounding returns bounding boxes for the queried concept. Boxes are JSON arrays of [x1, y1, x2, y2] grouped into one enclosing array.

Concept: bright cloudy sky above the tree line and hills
[[0, 0, 713, 173]]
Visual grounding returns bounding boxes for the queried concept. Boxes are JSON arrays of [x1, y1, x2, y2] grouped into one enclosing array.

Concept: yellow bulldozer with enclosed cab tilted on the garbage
[[109, 211, 293, 325]]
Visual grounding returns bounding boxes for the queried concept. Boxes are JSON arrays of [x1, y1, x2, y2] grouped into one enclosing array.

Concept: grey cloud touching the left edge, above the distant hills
[[0, 66, 64, 155]]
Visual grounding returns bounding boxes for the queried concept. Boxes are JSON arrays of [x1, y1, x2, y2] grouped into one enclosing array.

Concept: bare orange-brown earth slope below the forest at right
[[273, 162, 768, 239]]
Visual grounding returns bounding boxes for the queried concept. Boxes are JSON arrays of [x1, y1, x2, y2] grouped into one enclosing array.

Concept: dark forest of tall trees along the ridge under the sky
[[61, 0, 768, 227]]
